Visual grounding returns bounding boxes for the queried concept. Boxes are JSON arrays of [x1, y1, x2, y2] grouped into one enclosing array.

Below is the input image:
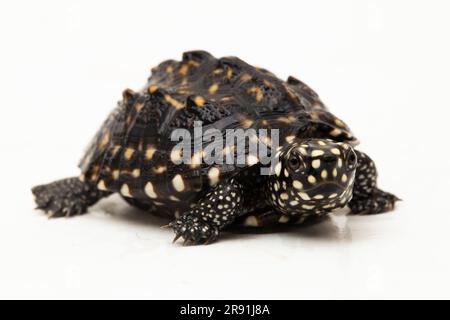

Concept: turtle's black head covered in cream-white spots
[[268, 139, 357, 214]]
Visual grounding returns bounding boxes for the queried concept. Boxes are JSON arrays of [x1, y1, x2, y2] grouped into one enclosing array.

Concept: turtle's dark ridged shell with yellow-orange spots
[[80, 51, 356, 214]]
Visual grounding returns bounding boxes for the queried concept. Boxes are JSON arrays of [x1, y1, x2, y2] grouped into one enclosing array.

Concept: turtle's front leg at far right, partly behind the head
[[348, 150, 400, 214]]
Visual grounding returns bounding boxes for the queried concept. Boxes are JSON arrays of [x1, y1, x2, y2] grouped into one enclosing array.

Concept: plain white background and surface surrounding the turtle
[[0, 0, 450, 299]]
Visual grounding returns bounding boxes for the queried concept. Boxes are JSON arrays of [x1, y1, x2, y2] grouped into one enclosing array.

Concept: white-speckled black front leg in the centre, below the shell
[[169, 179, 243, 244]]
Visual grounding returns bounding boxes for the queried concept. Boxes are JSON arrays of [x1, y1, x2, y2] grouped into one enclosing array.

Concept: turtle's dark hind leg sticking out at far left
[[31, 178, 110, 217]]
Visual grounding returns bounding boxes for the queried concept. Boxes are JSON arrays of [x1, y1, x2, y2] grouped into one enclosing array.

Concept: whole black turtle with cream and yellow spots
[[32, 50, 399, 245]]
